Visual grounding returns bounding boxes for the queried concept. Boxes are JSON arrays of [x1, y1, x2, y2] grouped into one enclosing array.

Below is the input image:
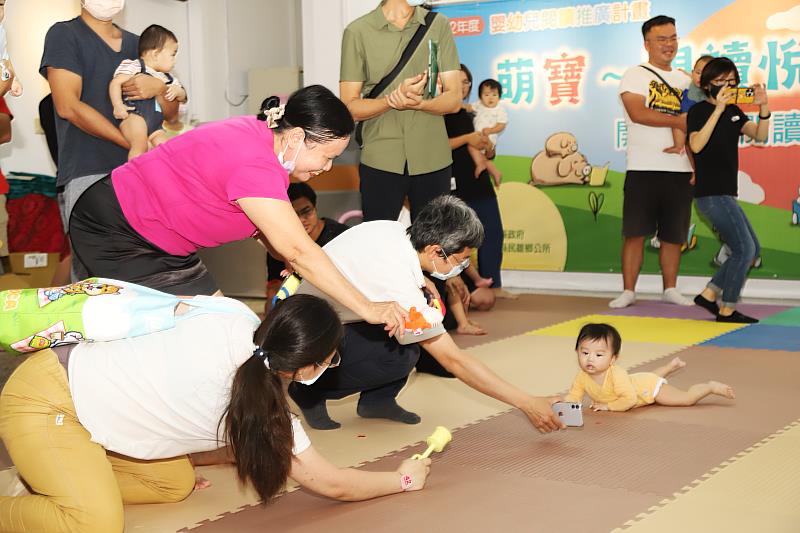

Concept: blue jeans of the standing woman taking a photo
[[695, 196, 761, 308]]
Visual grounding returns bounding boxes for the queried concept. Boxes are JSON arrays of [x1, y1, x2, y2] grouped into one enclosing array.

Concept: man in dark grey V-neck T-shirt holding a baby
[[39, 0, 178, 281]]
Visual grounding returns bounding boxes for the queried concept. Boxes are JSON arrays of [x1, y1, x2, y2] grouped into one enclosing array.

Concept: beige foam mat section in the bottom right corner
[[617, 422, 800, 533]]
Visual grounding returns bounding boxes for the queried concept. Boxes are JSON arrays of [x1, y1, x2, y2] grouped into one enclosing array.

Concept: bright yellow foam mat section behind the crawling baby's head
[[526, 315, 744, 350]]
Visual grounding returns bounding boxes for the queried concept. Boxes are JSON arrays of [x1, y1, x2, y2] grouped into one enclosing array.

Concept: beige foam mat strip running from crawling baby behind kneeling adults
[[125, 335, 684, 533]]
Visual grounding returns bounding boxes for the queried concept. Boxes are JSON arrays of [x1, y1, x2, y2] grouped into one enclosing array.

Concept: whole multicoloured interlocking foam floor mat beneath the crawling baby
[[0, 295, 800, 533]]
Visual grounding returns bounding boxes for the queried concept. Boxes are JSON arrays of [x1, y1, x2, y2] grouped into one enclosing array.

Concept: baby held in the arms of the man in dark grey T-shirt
[[108, 24, 186, 160]]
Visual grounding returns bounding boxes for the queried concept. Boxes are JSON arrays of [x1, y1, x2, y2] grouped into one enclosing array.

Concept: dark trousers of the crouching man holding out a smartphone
[[291, 322, 419, 409]]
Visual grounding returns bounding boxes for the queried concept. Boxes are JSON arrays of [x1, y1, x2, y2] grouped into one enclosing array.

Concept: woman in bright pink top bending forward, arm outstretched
[[70, 85, 405, 333]]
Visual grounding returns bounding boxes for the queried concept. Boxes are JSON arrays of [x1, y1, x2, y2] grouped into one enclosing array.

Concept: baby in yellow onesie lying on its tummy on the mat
[[564, 324, 735, 411]]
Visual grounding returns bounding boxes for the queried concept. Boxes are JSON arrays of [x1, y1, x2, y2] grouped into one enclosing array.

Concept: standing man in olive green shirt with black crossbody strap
[[339, 0, 461, 221]]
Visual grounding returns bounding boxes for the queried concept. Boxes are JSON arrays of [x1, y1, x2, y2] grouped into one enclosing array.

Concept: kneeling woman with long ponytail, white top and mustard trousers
[[0, 295, 430, 533]]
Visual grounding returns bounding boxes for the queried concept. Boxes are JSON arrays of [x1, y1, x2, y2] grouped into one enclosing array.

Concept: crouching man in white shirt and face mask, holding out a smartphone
[[289, 196, 562, 432]]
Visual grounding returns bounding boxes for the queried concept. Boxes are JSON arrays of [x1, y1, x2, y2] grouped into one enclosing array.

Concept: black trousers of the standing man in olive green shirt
[[358, 165, 452, 222]]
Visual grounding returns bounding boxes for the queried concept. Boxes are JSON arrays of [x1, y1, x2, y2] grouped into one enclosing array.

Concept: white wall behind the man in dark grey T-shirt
[[0, 0, 302, 179]]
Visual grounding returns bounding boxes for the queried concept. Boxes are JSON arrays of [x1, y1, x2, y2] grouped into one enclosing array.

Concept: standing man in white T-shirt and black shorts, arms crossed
[[609, 15, 692, 307]]
